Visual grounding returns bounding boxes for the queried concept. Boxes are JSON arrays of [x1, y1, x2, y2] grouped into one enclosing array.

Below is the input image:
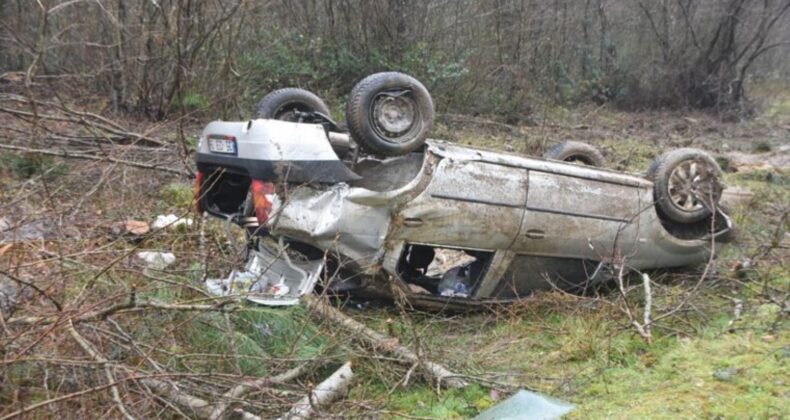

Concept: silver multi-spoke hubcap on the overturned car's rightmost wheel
[[669, 160, 710, 212]]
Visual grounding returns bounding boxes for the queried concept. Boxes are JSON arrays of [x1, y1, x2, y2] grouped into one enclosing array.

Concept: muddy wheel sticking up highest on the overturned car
[[346, 72, 434, 156]]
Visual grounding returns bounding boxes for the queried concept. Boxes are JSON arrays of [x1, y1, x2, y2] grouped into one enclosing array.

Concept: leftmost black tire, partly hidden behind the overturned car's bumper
[[255, 88, 329, 122]]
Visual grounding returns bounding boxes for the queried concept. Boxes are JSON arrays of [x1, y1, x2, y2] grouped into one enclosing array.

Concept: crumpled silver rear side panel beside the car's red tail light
[[269, 183, 392, 269]]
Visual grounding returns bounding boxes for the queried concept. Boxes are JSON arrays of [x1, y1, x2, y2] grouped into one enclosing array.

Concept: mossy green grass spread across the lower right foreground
[[351, 290, 790, 418]]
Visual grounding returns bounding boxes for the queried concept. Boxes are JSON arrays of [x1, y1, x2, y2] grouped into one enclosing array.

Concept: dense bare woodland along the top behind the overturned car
[[0, 0, 790, 122]]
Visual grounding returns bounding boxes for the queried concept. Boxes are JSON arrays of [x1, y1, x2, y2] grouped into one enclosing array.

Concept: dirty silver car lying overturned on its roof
[[197, 73, 732, 307]]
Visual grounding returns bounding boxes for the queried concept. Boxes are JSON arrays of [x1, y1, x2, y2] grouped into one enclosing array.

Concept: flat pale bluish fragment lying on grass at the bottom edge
[[475, 389, 576, 420]]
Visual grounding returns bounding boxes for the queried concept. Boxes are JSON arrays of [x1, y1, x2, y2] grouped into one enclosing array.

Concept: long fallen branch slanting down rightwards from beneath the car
[[303, 295, 469, 388]]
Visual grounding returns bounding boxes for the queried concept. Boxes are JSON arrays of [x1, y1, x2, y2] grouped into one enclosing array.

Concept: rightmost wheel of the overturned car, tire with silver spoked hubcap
[[647, 149, 724, 224]]
